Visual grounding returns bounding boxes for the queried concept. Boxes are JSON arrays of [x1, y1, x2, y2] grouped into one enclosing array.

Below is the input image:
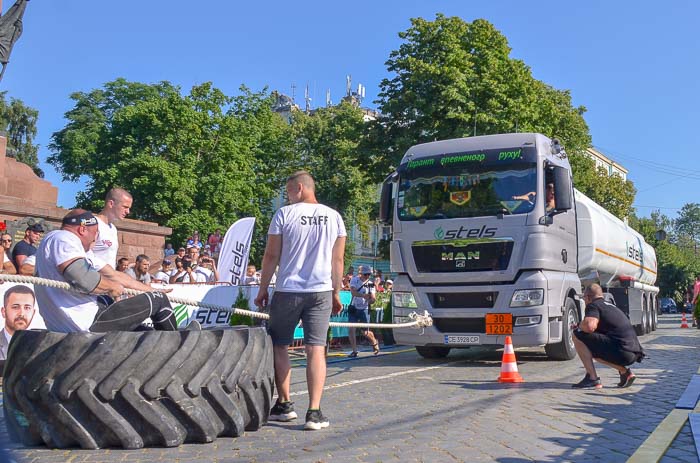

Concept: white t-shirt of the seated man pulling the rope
[[34, 230, 97, 333]]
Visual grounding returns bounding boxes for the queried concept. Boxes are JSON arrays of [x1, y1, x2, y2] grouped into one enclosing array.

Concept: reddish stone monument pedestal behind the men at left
[[0, 137, 172, 266]]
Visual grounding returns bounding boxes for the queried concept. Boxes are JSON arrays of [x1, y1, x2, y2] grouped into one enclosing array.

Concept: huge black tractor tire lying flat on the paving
[[3, 327, 274, 449]]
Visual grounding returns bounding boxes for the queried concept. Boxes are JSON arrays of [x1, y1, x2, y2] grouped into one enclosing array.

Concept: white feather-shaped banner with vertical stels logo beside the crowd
[[218, 217, 255, 286]]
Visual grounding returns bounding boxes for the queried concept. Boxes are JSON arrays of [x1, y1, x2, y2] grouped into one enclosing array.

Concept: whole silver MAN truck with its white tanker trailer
[[380, 133, 659, 360]]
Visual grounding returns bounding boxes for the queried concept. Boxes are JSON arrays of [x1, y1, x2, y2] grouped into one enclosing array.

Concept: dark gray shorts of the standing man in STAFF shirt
[[267, 291, 333, 346]]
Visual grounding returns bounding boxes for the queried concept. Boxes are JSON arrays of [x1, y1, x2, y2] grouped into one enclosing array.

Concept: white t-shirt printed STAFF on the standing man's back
[[268, 203, 347, 293]]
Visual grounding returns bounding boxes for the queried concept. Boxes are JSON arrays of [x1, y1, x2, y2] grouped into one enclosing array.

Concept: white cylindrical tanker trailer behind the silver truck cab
[[574, 190, 659, 335]]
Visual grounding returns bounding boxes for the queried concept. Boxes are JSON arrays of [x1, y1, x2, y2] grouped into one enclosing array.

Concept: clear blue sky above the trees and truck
[[0, 0, 700, 217]]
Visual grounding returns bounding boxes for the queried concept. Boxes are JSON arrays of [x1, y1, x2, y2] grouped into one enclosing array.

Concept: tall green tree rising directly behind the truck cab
[[374, 14, 635, 222]]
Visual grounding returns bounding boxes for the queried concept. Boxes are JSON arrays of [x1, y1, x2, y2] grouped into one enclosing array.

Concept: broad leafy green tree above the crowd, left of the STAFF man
[[48, 79, 288, 259]]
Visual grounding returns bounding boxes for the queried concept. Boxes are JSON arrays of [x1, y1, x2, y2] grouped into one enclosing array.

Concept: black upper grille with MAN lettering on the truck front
[[411, 241, 513, 273]]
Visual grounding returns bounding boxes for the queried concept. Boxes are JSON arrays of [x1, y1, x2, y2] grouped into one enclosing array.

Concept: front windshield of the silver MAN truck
[[397, 161, 537, 221]]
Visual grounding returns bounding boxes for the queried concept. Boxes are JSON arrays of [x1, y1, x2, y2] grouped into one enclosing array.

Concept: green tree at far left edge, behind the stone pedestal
[[0, 92, 44, 178]]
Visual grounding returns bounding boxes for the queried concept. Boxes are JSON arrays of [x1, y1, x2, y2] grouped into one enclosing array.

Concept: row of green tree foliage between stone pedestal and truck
[[48, 79, 376, 262]]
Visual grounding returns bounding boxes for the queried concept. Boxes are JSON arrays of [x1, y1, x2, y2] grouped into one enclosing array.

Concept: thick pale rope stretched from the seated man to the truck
[[0, 274, 433, 329]]
